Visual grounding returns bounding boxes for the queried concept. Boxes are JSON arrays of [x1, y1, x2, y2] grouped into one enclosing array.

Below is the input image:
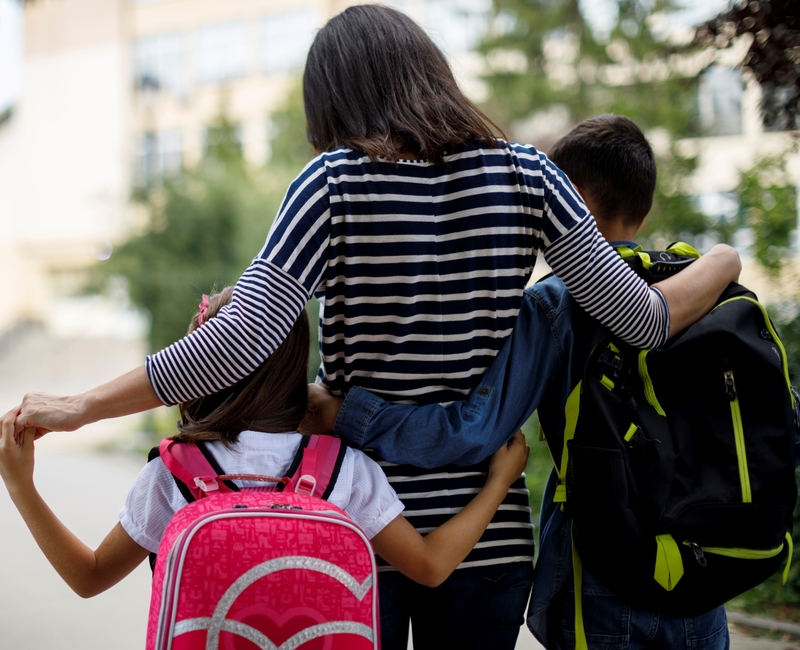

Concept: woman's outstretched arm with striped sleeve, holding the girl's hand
[[17, 157, 330, 436]]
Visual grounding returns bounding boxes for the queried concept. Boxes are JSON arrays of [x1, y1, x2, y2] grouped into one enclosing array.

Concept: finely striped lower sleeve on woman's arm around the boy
[[545, 219, 669, 348]]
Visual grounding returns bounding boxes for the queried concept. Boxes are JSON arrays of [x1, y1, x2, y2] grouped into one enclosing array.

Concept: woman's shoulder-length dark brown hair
[[303, 5, 502, 163]]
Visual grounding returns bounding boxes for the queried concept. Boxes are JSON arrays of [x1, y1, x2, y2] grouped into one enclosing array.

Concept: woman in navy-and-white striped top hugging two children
[[12, 5, 739, 650]]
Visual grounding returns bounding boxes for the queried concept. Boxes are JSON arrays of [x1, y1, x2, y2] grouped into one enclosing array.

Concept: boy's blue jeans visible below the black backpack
[[548, 568, 730, 650]]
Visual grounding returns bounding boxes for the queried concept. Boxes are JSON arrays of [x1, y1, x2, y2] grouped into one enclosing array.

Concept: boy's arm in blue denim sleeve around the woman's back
[[304, 293, 571, 469]]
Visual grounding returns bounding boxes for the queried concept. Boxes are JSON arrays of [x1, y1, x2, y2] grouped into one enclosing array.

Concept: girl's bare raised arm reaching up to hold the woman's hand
[[0, 409, 148, 598]]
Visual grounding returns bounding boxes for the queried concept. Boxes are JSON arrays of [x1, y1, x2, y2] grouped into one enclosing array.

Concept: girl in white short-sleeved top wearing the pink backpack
[[0, 287, 528, 598]]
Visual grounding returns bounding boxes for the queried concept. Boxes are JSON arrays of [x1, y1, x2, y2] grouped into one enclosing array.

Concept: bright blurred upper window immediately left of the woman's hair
[[261, 8, 317, 74]]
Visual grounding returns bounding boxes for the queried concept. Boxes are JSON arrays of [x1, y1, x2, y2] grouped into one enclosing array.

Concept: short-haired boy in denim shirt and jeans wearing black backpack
[[314, 115, 729, 650]]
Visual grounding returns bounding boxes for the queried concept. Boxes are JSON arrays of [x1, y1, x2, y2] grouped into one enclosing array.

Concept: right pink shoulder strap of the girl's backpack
[[284, 435, 347, 499]]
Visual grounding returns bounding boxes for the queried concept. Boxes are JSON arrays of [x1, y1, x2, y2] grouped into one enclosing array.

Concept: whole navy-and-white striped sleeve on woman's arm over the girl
[[146, 158, 330, 405]]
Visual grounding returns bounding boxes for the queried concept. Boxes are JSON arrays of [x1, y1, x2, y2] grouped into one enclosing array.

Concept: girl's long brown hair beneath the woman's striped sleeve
[[175, 287, 309, 445]]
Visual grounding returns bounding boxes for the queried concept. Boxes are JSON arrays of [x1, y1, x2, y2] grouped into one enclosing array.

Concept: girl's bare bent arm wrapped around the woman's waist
[[372, 431, 529, 587]]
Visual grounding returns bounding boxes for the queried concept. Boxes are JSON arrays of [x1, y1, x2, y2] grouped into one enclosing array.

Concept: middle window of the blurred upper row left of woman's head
[[197, 23, 247, 83]]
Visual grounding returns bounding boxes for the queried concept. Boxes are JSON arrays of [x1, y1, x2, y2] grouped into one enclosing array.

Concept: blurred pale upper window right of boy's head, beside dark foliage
[[698, 66, 744, 135]]
